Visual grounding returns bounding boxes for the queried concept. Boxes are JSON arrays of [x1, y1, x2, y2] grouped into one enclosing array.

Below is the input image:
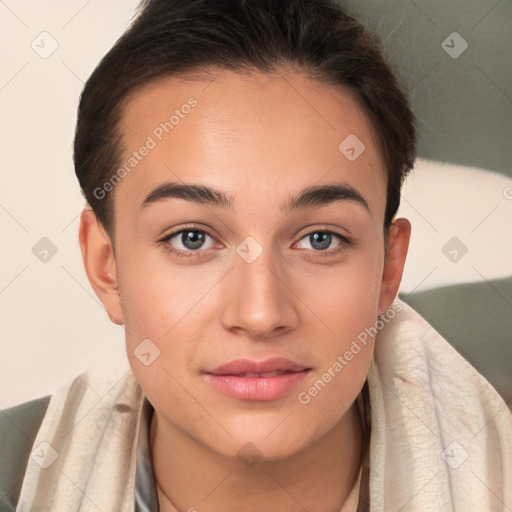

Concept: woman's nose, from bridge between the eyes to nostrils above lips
[[222, 244, 299, 339]]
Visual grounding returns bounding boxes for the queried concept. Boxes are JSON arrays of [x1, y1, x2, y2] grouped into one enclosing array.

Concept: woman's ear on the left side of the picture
[[78, 206, 123, 325]]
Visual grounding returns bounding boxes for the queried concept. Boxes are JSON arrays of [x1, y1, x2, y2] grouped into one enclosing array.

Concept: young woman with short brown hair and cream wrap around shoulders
[[3, 0, 512, 512]]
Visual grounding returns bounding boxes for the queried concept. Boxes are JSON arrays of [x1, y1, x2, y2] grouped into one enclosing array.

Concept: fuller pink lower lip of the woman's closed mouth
[[205, 370, 309, 400]]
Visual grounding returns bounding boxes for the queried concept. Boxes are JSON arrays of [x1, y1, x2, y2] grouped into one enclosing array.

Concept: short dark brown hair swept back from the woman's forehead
[[74, 0, 416, 241]]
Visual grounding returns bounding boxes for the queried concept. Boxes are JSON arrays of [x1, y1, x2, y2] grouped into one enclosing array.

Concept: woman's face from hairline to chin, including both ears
[[81, 67, 408, 459]]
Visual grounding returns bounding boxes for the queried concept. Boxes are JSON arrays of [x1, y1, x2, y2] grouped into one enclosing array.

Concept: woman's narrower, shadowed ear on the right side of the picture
[[379, 219, 411, 315]]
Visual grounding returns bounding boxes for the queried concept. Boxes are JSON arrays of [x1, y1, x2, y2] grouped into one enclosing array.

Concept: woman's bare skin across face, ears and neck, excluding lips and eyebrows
[[80, 71, 410, 512]]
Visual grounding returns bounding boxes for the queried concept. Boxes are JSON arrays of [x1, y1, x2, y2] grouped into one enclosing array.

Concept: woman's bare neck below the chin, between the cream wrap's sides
[[149, 403, 363, 512]]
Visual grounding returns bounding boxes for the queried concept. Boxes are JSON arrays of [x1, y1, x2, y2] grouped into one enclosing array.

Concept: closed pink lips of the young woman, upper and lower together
[[204, 357, 311, 401]]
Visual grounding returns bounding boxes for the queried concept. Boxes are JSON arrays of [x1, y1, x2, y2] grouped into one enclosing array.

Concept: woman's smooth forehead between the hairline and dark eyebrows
[[115, 70, 386, 218]]
